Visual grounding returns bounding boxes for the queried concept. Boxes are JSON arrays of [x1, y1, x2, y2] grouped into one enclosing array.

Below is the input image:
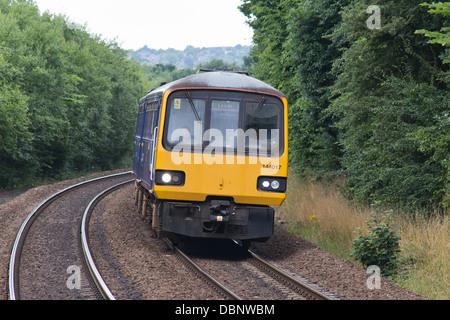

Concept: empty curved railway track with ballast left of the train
[[8, 172, 134, 300]]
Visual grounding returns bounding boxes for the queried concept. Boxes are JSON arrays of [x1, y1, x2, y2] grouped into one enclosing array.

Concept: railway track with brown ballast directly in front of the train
[[164, 238, 337, 300]]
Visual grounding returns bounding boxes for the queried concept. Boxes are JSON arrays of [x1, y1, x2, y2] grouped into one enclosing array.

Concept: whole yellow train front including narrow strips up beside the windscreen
[[154, 92, 288, 206]]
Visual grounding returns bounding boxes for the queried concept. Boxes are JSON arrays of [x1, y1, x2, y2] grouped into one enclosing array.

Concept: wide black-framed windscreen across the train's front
[[164, 90, 284, 157]]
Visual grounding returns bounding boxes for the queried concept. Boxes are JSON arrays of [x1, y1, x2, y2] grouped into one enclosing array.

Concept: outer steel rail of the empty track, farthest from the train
[[8, 171, 132, 300]]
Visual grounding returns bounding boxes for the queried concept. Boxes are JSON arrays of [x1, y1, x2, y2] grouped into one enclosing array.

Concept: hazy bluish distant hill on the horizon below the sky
[[129, 45, 251, 69]]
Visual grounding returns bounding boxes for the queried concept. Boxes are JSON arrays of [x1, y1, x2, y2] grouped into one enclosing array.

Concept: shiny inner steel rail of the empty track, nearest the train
[[80, 179, 134, 300]]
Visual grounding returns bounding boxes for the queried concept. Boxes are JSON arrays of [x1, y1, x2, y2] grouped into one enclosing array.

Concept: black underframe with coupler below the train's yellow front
[[135, 182, 275, 244]]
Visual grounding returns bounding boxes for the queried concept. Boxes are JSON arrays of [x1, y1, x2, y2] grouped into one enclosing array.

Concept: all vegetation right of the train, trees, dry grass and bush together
[[240, 0, 450, 299]]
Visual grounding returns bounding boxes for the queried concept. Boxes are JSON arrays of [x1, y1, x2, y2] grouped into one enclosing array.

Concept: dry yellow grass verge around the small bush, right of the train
[[279, 175, 450, 300]]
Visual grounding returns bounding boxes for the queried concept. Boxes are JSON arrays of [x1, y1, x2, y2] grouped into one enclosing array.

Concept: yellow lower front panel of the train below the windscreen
[[154, 148, 287, 206]]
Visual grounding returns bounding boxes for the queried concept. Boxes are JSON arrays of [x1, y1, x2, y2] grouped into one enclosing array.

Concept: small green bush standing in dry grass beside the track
[[351, 202, 400, 276]]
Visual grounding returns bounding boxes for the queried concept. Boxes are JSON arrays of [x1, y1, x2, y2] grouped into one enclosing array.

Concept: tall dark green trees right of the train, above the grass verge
[[240, 0, 450, 208]]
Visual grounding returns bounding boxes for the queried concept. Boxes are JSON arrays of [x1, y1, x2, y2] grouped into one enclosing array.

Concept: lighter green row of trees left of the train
[[0, 0, 149, 188]]
